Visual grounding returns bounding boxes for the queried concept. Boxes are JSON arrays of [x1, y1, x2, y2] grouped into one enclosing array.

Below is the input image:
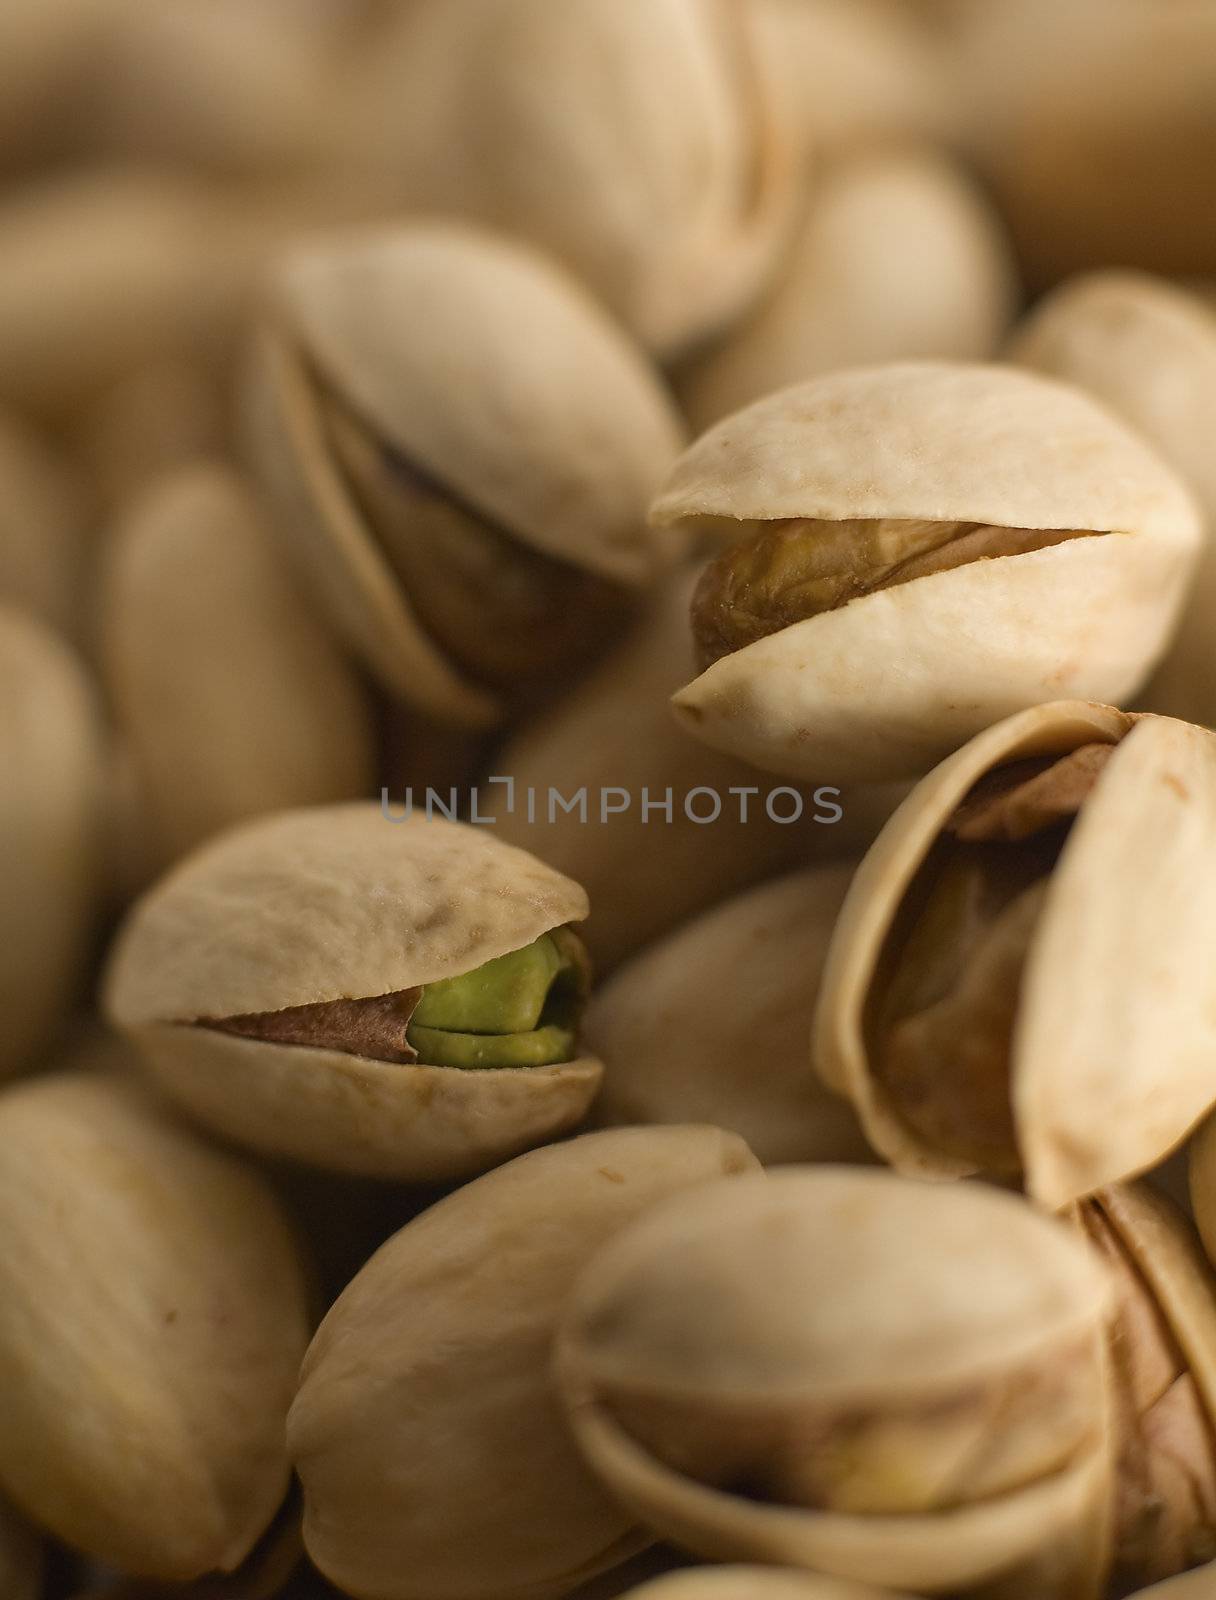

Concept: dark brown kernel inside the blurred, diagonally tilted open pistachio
[[322, 392, 629, 688]]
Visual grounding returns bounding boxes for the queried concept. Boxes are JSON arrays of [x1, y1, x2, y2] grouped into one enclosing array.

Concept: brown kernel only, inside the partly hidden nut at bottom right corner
[[1078, 1194, 1216, 1592]]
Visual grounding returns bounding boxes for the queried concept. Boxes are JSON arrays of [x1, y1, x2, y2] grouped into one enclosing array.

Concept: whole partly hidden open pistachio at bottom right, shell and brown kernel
[[1075, 1184, 1216, 1594]]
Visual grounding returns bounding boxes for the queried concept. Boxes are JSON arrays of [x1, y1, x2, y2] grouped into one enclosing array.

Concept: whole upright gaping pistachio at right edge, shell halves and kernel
[[814, 702, 1216, 1208]]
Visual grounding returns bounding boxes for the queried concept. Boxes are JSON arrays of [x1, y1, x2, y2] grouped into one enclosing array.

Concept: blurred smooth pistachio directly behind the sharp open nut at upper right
[[678, 147, 1014, 432]]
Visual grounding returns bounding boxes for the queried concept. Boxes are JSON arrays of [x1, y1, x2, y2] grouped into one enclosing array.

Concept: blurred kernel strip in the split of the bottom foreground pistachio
[[608, 1338, 1101, 1515]]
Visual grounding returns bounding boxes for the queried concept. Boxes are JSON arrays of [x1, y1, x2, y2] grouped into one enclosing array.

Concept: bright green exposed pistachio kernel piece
[[406, 928, 589, 1070]]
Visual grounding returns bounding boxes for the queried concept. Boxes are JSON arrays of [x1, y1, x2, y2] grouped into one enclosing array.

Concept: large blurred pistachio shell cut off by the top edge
[[342, 0, 803, 357]]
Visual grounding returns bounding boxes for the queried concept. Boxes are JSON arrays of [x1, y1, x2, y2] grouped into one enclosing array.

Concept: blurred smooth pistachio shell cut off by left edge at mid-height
[[0, 608, 104, 1078]]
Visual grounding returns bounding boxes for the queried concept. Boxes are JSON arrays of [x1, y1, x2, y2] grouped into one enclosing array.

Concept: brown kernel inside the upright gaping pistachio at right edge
[[866, 744, 1114, 1174]]
